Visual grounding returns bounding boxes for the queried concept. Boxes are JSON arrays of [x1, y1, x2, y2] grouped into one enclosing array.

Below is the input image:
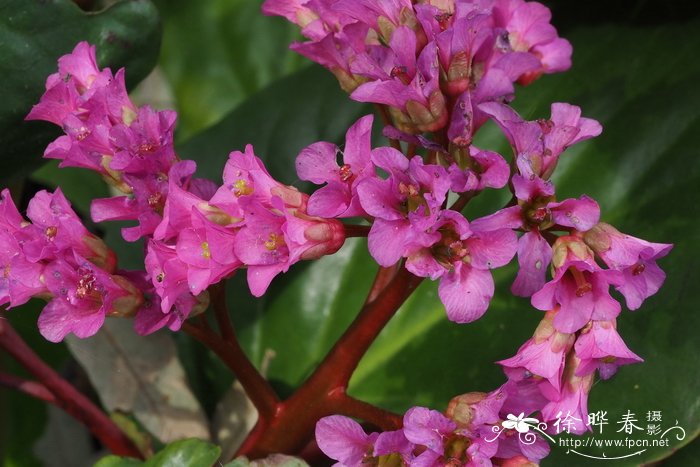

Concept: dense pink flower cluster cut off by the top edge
[[263, 0, 571, 139]]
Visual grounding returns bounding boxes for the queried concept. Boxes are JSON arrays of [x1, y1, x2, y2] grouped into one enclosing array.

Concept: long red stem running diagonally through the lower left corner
[[0, 319, 143, 459]]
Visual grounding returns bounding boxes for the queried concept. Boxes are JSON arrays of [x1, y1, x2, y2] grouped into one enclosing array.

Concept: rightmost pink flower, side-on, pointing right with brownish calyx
[[584, 222, 673, 310]]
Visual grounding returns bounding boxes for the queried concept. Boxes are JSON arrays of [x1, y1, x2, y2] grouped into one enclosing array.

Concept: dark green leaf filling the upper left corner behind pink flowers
[[0, 0, 160, 183]]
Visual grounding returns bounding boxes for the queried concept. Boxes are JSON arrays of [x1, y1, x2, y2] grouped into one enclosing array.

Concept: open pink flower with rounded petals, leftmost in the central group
[[296, 115, 374, 217]]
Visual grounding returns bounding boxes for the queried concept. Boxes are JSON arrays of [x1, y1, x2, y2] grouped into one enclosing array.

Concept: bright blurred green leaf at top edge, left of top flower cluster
[[157, 0, 306, 140]]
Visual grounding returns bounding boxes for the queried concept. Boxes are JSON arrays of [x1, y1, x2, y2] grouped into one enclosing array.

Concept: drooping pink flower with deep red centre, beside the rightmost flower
[[532, 236, 621, 333]]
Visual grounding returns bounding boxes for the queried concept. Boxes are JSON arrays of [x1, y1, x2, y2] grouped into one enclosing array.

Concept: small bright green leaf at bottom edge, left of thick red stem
[[95, 438, 221, 467]]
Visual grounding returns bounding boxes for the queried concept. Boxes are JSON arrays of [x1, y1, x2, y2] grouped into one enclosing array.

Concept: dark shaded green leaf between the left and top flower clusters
[[178, 66, 371, 184]]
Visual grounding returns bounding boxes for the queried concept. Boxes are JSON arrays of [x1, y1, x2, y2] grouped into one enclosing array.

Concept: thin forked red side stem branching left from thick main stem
[[182, 286, 279, 421]]
